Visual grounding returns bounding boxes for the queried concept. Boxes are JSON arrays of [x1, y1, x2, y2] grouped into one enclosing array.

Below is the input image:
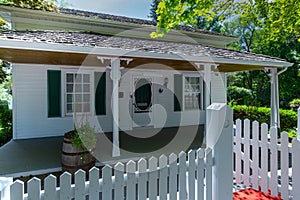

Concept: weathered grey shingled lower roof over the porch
[[0, 31, 284, 63]]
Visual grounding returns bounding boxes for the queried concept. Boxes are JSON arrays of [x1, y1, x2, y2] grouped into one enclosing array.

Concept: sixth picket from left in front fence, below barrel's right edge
[[89, 167, 100, 200]]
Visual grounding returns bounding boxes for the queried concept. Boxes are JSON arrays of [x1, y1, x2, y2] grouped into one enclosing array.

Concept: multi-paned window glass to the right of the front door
[[184, 76, 202, 110]]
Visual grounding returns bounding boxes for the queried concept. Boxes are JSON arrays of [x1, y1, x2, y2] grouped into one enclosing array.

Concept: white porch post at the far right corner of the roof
[[270, 68, 280, 129]]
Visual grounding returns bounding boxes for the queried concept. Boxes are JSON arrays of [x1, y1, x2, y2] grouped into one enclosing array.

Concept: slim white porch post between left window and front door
[[110, 58, 121, 157]]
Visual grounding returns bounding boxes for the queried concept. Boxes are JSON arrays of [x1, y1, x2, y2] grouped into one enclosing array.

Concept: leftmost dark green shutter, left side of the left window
[[47, 70, 61, 117]]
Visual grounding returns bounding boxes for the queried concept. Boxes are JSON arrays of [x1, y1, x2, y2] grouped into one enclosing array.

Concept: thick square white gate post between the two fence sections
[[206, 103, 233, 200]]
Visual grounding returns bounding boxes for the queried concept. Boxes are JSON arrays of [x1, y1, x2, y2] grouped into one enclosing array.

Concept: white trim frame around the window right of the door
[[182, 73, 204, 111]]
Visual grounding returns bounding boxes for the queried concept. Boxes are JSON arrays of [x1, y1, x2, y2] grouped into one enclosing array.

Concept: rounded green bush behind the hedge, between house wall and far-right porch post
[[227, 86, 253, 105]]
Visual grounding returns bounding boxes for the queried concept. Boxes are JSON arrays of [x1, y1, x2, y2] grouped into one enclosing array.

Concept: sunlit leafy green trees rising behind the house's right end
[[152, 0, 300, 107]]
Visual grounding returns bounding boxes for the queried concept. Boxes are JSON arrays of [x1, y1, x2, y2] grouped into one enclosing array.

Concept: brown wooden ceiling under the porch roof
[[0, 48, 265, 72]]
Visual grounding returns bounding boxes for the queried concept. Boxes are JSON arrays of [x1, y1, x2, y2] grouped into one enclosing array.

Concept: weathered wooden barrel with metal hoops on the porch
[[61, 135, 96, 173]]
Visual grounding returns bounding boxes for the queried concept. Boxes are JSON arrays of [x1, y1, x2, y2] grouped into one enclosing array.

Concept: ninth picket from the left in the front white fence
[[126, 160, 136, 200]]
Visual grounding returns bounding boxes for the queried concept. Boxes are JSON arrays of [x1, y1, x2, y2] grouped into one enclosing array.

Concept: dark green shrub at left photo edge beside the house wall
[[0, 100, 12, 146]]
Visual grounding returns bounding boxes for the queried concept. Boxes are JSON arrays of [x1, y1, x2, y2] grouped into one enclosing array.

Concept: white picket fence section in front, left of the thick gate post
[[10, 148, 213, 200]]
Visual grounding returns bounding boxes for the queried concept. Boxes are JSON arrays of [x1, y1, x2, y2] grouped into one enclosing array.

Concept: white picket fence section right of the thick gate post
[[234, 119, 300, 199]]
